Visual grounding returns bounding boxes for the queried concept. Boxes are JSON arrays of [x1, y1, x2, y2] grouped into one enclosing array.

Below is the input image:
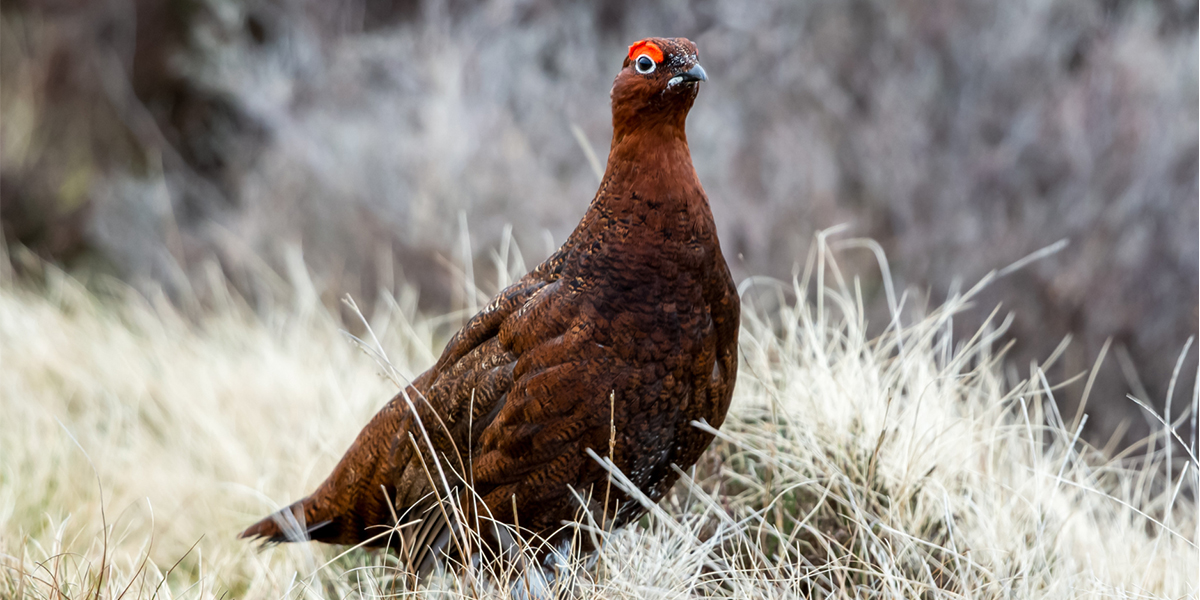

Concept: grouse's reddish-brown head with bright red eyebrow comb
[[611, 37, 708, 140]]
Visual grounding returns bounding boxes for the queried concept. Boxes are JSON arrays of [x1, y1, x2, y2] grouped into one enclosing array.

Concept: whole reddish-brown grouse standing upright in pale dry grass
[[240, 37, 740, 574]]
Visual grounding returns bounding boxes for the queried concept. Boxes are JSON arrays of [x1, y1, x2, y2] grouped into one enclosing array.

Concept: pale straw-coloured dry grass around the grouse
[[0, 236, 1200, 599]]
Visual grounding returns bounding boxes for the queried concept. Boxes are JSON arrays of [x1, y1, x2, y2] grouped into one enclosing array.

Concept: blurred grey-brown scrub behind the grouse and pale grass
[[0, 0, 1200, 444]]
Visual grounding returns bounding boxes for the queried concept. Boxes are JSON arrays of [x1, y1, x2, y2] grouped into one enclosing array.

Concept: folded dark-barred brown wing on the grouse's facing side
[[451, 283, 636, 542]]
